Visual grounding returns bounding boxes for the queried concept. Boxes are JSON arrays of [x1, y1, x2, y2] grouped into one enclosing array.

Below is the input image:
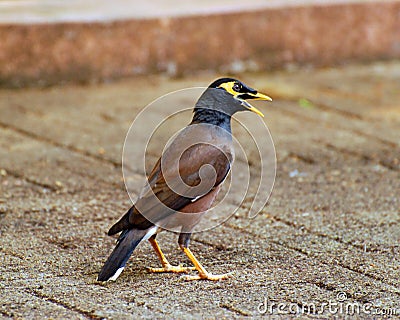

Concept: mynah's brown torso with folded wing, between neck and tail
[[117, 124, 234, 233]]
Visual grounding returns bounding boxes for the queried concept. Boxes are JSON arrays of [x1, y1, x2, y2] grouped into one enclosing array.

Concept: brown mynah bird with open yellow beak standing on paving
[[98, 78, 272, 281]]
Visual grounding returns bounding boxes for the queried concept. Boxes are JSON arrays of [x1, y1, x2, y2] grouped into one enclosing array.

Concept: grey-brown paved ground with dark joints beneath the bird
[[0, 62, 400, 319]]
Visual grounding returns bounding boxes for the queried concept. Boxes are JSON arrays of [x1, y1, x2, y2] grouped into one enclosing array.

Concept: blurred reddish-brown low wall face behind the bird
[[0, 1, 400, 87]]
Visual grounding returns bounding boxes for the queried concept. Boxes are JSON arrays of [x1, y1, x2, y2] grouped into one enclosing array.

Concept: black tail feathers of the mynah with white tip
[[97, 229, 149, 281]]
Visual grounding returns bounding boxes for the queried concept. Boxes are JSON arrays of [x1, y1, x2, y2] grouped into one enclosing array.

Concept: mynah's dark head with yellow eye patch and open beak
[[195, 78, 272, 117]]
